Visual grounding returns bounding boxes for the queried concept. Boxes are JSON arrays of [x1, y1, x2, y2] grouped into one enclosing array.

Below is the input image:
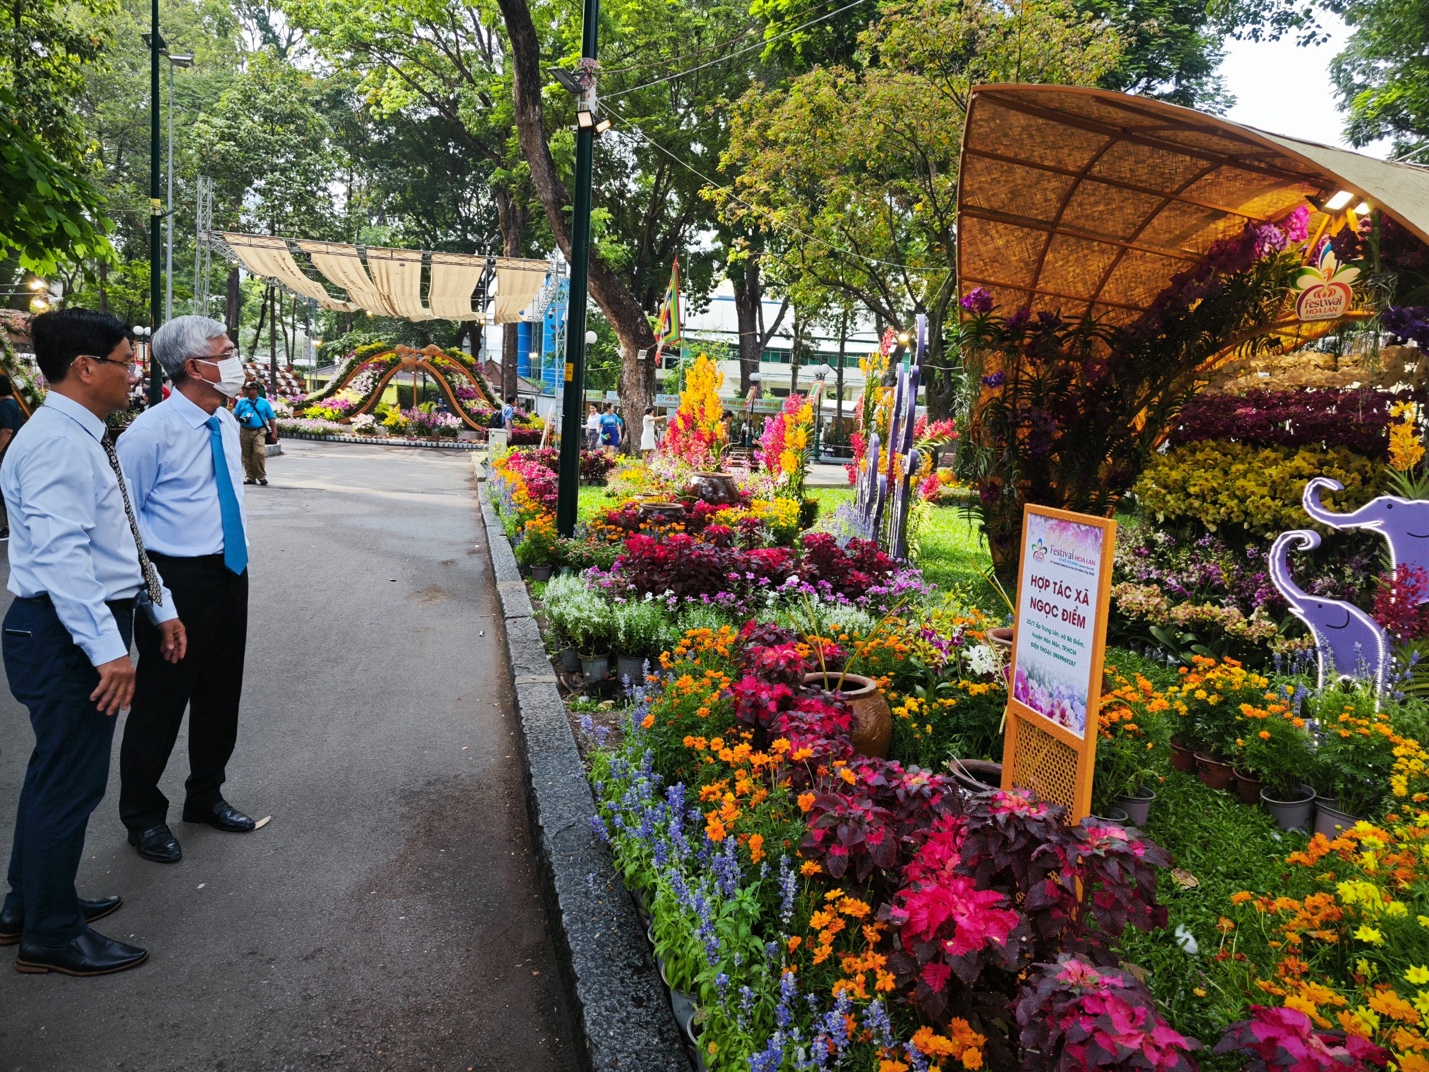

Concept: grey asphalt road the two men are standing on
[[0, 442, 579, 1072]]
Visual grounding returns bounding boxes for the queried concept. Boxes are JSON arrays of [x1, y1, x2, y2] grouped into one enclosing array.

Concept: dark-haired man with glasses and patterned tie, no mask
[[0, 309, 187, 975]]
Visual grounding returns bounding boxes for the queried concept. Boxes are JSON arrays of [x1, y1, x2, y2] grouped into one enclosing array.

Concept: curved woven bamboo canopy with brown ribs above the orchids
[[957, 84, 1429, 324]]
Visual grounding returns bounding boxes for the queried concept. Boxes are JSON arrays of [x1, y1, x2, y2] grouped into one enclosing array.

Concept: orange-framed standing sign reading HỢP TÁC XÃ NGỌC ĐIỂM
[[1002, 505, 1116, 822]]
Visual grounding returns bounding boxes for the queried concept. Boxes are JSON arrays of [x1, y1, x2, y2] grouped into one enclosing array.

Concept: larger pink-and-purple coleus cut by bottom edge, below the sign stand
[[1016, 955, 1200, 1072]]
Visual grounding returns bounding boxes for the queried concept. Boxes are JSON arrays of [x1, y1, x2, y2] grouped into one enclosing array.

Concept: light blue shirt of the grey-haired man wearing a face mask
[[117, 390, 247, 559]]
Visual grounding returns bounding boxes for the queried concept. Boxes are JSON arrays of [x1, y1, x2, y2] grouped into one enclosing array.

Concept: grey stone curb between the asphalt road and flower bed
[[473, 459, 690, 1072]]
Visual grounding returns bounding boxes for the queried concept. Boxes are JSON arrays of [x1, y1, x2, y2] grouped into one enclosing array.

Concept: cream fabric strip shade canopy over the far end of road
[[219, 232, 550, 324]]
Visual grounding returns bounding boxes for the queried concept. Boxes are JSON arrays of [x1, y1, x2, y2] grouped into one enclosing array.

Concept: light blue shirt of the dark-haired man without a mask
[[0, 390, 179, 666]]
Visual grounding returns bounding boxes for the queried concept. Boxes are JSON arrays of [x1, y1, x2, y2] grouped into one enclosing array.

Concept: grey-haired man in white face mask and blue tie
[[119, 316, 254, 863]]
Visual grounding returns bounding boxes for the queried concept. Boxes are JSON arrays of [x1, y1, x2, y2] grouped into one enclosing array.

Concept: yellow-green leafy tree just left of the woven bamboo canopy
[[710, 0, 1122, 416]]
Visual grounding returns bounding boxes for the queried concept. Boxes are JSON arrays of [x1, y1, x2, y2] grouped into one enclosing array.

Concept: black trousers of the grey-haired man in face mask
[[119, 552, 249, 832]]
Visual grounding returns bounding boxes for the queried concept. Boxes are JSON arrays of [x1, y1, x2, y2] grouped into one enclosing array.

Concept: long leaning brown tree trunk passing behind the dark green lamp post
[[497, 0, 654, 425]]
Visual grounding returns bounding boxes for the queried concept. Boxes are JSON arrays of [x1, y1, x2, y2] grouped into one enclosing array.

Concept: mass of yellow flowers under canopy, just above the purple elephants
[[1135, 439, 1385, 535]]
